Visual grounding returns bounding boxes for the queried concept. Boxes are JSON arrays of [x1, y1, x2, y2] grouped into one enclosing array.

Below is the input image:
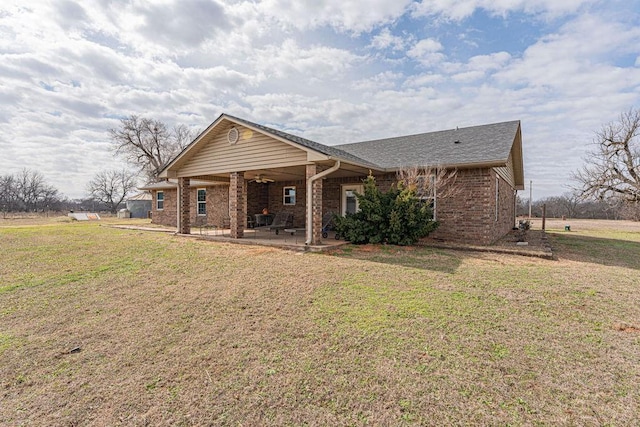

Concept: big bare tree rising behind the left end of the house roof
[[109, 115, 193, 182]]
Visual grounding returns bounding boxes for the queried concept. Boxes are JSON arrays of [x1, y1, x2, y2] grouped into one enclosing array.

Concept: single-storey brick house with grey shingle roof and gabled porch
[[142, 114, 524, 245]]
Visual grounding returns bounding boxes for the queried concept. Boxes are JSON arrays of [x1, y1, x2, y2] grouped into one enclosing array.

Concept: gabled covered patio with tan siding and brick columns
[[160, 115, 380, 246]]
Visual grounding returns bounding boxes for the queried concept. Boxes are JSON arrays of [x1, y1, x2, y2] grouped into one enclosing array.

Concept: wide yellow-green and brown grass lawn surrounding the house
[[0, 219, 640, 426]]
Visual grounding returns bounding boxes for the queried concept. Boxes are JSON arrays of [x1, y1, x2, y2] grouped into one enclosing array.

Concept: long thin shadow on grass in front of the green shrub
[[327, 245, 462, 273]]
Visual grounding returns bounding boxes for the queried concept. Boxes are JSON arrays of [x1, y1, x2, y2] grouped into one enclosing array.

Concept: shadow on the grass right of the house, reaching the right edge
[[547, 232, 640, 270]]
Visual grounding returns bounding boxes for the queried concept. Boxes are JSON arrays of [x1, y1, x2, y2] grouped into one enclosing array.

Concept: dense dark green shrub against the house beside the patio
[[334, 175, 438, 246]]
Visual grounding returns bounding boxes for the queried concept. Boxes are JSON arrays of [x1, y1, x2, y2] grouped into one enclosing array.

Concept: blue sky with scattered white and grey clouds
[[0, 0, 640, 199]]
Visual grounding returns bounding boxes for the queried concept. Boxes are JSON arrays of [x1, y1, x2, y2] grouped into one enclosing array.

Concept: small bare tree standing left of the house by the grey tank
[[87, 169, 136, 213]]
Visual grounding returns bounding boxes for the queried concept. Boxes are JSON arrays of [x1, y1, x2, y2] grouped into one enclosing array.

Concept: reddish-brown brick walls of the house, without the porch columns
[[152, 168, 515, 245]]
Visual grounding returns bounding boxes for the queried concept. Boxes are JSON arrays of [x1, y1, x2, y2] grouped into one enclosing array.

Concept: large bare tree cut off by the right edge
[[573, 108, 640, 206]]
